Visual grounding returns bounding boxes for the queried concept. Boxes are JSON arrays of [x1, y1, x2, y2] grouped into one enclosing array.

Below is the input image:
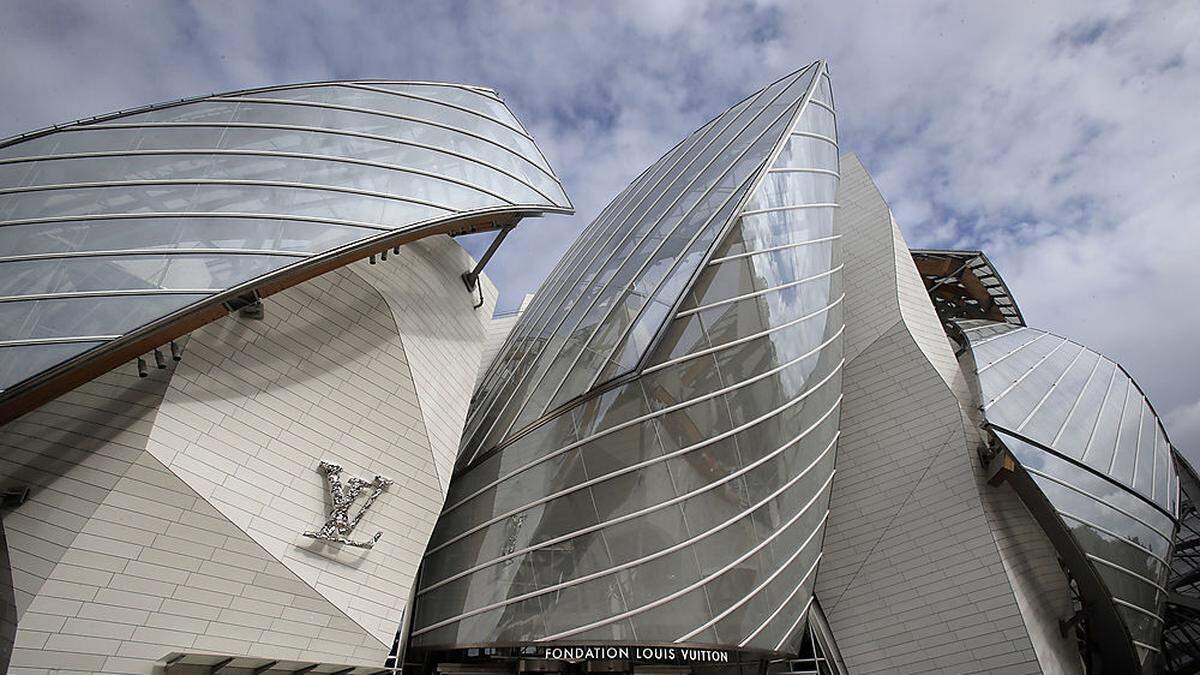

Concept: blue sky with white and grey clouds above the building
[[0, 0, 1200, 461]]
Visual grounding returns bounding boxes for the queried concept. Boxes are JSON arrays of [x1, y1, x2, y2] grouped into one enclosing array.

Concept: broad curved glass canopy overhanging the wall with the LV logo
[[0, 82, 570, 389]]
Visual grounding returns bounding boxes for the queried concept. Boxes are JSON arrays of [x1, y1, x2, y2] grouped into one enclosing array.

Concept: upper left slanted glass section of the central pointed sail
[[460, 66, 833, 467]]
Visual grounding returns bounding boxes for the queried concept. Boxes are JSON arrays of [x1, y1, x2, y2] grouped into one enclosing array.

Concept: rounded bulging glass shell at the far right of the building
[[958, 321, 1178, 669]]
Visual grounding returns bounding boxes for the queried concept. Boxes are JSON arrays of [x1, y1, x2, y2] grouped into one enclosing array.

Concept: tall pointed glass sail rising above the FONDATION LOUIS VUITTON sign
[[412, 64, 844, 653]]
